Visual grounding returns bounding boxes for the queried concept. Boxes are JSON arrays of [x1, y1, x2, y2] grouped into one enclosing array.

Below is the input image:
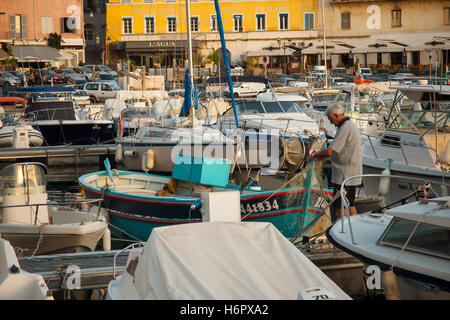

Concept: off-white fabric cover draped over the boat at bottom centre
[[134, 222, 350, 300]]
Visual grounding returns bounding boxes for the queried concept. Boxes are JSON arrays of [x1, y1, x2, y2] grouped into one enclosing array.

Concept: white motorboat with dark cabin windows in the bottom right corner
[[327, 192, 450, 300]]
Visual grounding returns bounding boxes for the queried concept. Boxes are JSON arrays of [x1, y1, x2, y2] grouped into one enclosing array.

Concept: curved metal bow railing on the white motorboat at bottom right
[[339, 173, 450, 245]]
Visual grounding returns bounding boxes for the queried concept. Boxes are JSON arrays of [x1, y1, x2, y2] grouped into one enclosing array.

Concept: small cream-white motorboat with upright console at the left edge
[[0, 162, 111, 256]]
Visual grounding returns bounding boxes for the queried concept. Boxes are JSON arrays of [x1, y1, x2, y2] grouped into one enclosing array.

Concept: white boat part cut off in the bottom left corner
[[0, 239, 53, 300]]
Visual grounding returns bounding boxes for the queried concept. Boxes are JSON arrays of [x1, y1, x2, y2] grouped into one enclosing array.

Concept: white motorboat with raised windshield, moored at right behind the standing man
[[362, 86, 450, 202]]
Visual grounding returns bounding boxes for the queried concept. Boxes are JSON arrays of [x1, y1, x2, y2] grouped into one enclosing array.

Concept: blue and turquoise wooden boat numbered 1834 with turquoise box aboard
[[79, 157, 332, 241]]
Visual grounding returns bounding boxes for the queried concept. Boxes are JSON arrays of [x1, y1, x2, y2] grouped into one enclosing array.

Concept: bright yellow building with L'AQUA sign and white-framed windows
[[106, 0, 318, 71]]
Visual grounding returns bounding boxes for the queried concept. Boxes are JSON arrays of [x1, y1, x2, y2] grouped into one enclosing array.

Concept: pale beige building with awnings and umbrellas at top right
[[318, 0, 450, 69]]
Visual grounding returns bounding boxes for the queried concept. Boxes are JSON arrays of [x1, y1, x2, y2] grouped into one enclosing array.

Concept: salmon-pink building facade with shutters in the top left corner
[[0, 0, 84, 66]]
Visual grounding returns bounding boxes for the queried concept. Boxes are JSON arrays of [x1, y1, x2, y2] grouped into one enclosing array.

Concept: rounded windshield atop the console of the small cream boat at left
[[0, 164, 47, 195]]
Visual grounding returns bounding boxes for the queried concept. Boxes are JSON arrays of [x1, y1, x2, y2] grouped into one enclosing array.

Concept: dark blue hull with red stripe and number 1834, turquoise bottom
[[79, 171, 331, 241]]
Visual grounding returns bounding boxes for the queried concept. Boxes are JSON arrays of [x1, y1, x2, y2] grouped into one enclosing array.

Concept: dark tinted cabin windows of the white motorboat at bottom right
[[378, 218, 450, 259]]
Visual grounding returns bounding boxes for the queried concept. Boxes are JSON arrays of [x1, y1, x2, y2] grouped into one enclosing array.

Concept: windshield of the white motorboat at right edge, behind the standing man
[[389, 111, 450, 132]]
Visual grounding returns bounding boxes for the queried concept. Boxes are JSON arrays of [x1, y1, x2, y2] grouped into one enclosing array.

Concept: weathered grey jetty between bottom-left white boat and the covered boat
[[18, 250, 129, 291]]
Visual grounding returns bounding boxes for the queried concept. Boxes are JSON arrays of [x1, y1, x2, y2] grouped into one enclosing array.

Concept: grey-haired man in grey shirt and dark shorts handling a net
[[308, 104, 362, 222]]
